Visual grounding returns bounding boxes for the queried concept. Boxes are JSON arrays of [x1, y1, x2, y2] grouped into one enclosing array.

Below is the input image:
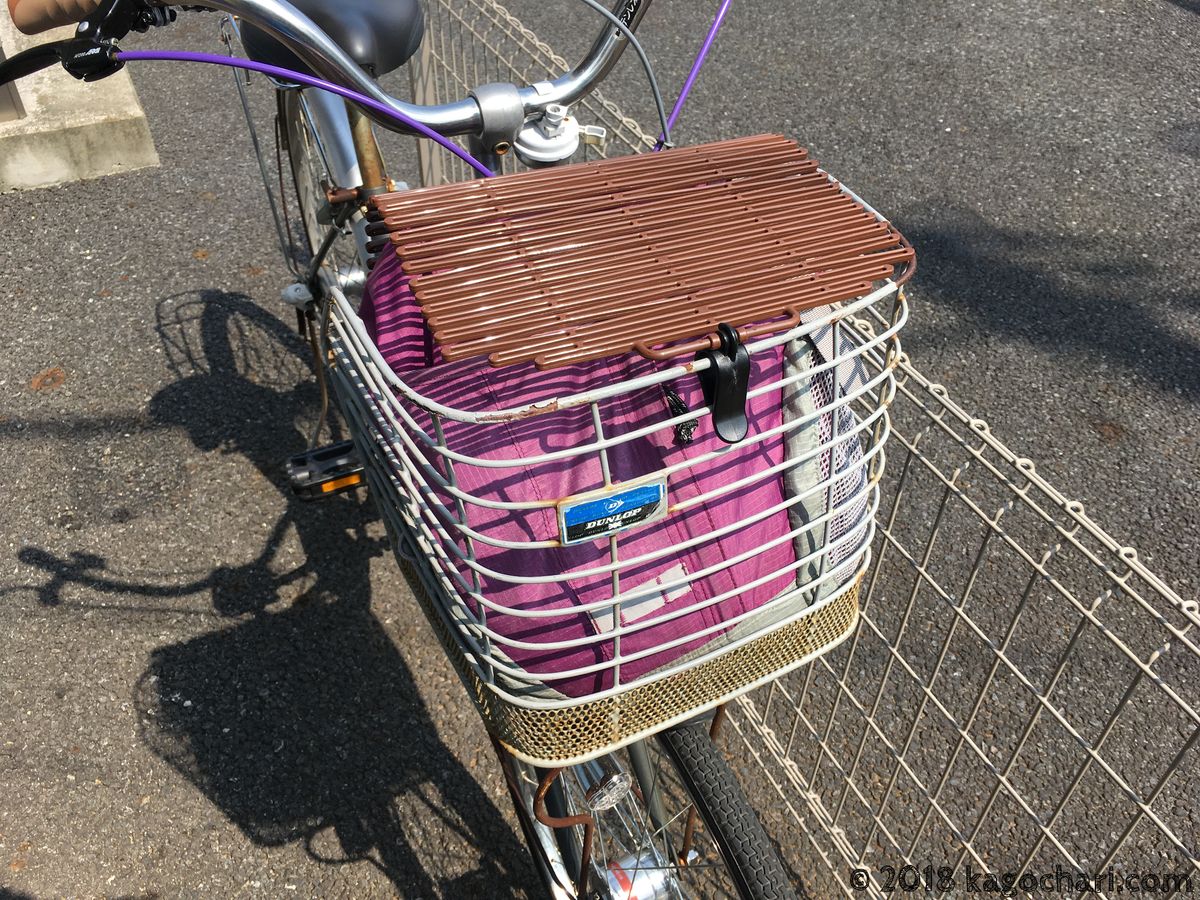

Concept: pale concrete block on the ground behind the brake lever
[[0, 11, 158, 191]]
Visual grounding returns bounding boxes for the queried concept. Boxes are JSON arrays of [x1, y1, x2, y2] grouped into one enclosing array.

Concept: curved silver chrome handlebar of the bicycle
[[203, 0, 652, 137]]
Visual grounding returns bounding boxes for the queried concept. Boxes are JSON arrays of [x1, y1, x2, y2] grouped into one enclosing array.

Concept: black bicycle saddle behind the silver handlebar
[[241, 0, 425, 77]]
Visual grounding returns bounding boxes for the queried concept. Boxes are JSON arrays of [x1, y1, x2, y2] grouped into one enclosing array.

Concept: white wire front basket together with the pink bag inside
[[331, 255, 906, 766]]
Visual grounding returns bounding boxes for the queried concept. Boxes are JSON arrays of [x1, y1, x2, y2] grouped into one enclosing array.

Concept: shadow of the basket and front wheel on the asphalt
[[134, 601, 535, 898]]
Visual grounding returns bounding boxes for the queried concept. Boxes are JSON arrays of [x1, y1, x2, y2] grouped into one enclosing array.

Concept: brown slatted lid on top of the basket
[[373, 134, 913, 368]]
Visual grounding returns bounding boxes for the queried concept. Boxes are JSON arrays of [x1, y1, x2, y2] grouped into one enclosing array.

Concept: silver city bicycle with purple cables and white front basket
[[0, 0, 911, 898]]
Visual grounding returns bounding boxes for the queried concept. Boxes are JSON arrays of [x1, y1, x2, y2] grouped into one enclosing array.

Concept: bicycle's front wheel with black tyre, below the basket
[[500, 720, 796, 900]]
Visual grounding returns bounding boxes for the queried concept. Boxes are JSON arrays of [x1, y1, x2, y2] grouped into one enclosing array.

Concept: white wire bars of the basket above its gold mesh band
[[329, 273, 907, 708]]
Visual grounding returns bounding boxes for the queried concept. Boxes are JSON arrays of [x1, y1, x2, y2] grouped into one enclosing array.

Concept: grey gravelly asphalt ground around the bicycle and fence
[[0, 0, 1200, 898]]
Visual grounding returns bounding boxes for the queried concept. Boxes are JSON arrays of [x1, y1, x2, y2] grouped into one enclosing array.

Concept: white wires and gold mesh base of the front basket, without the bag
[[330, 236, 906, 766]]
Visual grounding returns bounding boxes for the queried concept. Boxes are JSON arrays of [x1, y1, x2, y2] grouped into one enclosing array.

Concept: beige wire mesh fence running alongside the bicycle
[[413, 0, 1200, 898]]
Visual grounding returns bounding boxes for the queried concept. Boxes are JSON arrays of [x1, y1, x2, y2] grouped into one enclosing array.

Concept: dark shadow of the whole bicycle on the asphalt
[[22, 292, 532, 898]]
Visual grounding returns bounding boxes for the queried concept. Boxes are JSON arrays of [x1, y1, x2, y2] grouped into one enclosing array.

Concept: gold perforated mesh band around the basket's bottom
[[398, 557, 860, 766]]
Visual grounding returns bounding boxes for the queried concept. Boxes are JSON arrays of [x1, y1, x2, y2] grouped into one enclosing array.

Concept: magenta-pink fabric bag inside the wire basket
[[360, 253, 796, 697]]
